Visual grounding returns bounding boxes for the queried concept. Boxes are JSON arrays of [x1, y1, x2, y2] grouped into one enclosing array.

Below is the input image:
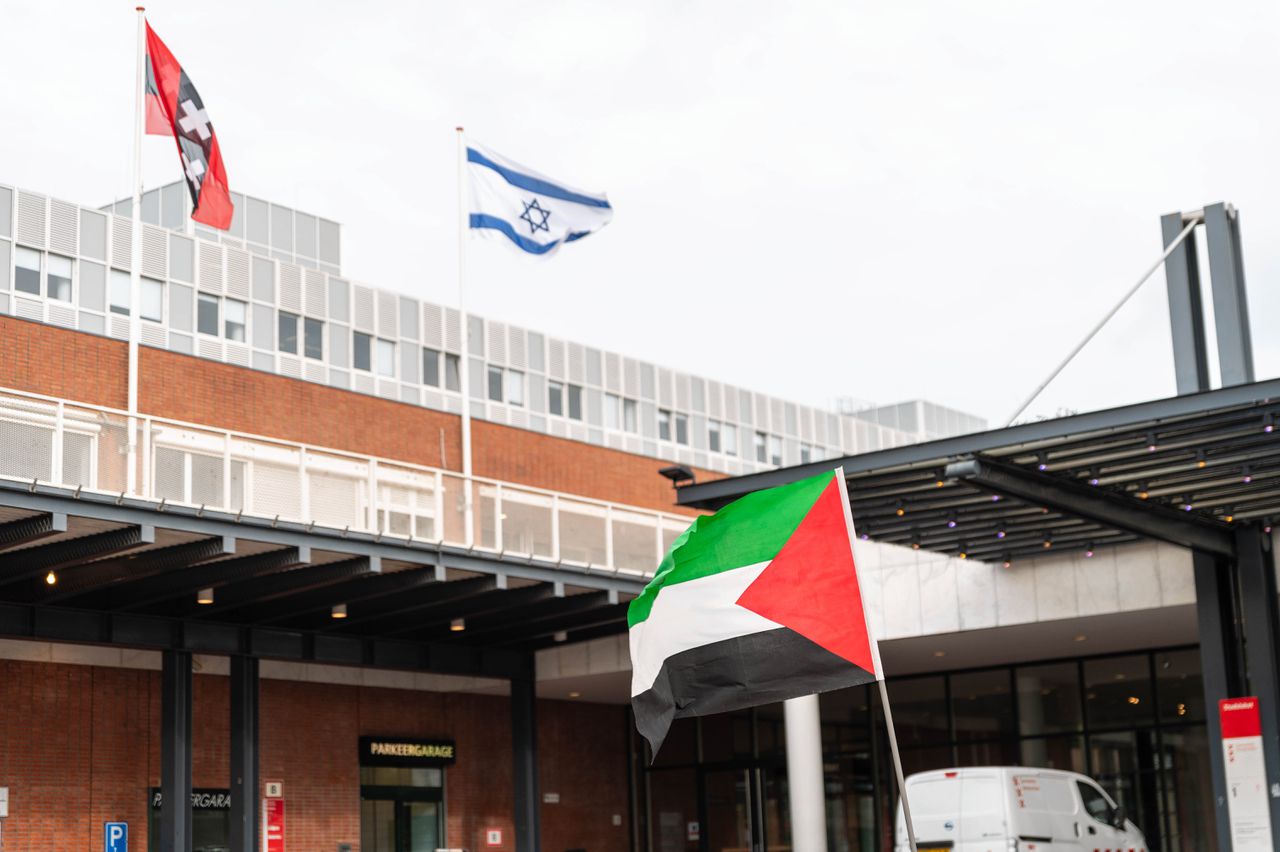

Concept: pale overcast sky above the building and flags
[[0, 0, 1280, 423]]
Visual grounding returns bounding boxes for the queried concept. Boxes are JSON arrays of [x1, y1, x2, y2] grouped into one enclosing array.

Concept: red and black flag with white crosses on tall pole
[[146, 23, 234, 230]]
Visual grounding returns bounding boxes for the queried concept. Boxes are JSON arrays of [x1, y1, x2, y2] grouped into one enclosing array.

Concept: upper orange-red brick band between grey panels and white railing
[[0, 317, 719, 513]]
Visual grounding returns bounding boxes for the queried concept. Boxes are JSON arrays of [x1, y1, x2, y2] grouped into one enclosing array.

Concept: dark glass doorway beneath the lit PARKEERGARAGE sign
[[360, 766, 444, 852]]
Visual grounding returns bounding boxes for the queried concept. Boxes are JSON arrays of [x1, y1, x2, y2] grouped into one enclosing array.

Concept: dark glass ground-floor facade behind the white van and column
[[635, 647, 1216, 852]]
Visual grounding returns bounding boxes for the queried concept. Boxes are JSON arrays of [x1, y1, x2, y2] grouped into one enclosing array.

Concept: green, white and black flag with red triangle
[[627, 469, 881, 755]]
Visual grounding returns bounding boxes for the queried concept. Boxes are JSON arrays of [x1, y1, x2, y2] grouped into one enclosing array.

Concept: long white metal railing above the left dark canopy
[[0, 389, 690, 577]]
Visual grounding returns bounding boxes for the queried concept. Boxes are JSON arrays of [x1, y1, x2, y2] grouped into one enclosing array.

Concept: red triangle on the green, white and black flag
[[737, 476, 877, 675]]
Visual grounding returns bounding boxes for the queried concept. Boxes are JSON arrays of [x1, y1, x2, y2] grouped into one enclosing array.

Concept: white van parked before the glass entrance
[[893, 766, 1147, 852]]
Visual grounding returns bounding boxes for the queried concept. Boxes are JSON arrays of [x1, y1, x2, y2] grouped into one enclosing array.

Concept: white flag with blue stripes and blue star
[[467, 142, 613, 255]]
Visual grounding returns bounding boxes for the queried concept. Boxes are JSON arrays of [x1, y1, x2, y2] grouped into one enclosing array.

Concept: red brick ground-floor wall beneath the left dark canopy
[[0, 660, 630, 852]]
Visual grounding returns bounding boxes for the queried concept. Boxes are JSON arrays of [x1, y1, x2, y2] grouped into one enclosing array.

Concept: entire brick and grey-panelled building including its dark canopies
[[0, 187, 1280, 852]]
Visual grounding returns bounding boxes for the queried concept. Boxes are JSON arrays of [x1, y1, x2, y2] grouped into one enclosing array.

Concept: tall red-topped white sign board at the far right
[[1217, 696, 1272, 852]]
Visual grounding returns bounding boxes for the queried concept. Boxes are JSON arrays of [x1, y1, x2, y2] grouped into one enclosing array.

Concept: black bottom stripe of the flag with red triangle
[[631, 627, 876, 759]]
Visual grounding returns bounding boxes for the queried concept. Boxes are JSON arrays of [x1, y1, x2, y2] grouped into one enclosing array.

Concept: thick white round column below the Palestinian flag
[[782, 695, 827, 852]]
